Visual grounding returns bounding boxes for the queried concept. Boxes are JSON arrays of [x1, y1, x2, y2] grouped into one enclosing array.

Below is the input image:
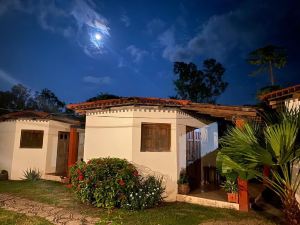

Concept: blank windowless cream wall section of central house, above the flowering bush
[[84, 109, 133, 161]]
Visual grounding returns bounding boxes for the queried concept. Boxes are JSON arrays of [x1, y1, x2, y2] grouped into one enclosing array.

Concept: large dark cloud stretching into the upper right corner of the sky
[[158, 1, 300, 61]]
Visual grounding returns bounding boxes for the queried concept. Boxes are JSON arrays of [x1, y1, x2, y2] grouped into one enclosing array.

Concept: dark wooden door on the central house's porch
[[186, 127, 201, 190]]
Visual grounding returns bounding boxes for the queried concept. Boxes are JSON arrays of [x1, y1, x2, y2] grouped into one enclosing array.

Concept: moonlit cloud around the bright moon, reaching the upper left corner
[[0, 0, 110, 57]]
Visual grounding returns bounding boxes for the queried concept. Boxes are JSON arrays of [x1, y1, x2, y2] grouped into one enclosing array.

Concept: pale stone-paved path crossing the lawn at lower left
[[0, 194, 99, 225]]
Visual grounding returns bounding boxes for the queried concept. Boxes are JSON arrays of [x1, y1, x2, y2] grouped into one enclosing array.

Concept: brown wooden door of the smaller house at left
[[56, 131, 70, 176]]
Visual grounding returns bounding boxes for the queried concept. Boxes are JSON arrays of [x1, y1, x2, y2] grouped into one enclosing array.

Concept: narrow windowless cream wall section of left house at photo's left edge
[[0, 121, 16, 178]]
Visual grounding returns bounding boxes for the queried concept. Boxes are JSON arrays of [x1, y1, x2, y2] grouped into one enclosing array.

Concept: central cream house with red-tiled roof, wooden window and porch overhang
[[67, 97, 256, 201]]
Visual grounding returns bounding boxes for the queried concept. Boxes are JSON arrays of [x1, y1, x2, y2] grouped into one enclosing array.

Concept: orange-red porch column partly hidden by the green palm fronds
[[235, 118, 250, 212]]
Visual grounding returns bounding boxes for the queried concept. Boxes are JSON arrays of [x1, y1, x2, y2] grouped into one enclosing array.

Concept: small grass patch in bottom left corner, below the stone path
[[0, 208, 52, 225]]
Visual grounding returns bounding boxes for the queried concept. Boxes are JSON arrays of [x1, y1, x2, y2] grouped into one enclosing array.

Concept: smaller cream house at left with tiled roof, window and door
[[0, 111, 84, 180]]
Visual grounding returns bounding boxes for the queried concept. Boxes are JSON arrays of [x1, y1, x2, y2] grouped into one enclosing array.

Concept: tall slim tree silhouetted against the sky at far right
[[247, 45, 287, 85]]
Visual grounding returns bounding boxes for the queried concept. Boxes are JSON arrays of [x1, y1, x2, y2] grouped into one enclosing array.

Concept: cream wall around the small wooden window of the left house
[[11, 120, 49, 180]]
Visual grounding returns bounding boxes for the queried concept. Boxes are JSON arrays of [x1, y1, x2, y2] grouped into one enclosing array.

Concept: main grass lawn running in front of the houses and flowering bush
[[0, 180, 278, 225]]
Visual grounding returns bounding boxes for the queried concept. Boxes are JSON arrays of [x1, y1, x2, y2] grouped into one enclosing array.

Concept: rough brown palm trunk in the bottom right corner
[[283, 190, 300, 225]]
